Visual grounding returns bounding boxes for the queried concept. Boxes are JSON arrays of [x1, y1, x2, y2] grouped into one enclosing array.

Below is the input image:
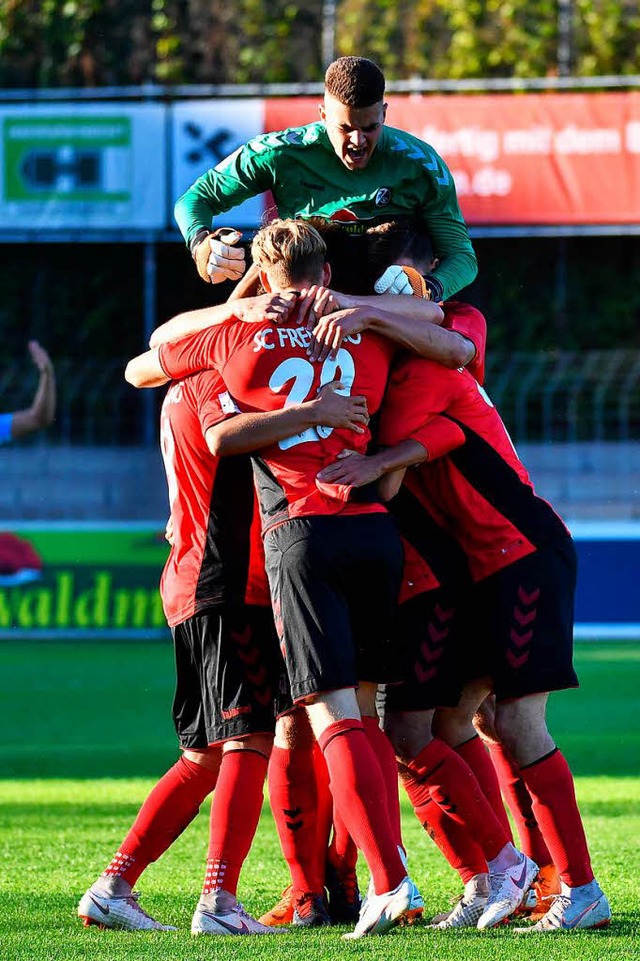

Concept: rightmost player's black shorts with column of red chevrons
[[465, 537, 578, 701]]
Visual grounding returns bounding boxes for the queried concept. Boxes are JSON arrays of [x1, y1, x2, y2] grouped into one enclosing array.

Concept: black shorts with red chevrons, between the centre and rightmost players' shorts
[[384, 587, 464, 712]]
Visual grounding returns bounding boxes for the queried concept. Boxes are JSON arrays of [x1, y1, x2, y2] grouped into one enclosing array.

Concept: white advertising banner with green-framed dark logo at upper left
[[0, 103, 167, 230]]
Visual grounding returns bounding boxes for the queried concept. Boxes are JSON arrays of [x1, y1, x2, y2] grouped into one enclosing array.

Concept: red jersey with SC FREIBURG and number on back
[[160, 322, 395, 529]]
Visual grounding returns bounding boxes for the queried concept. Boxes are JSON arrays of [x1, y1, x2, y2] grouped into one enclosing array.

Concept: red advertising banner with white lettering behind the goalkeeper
[[265, 92, 640, 225]]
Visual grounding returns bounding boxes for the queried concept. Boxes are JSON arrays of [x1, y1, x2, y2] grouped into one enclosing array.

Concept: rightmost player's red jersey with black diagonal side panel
[[378, 357, 568, 580]]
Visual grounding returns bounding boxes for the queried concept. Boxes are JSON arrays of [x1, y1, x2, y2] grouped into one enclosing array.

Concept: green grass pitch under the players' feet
[[0, 642, 640, 961]]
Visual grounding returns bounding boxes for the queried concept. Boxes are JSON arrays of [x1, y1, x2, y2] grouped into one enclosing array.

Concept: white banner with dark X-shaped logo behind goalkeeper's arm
[[171, 99, 265, 228]]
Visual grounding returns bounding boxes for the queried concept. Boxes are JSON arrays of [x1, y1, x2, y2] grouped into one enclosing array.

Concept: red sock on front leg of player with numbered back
[[318, 718, 405, 894]]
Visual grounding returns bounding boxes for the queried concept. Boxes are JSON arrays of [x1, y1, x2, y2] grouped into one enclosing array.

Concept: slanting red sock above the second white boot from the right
[[403, 737, 509, 861]]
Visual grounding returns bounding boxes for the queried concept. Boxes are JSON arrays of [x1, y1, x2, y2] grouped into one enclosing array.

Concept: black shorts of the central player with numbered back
[[265, 513, 403, 701]]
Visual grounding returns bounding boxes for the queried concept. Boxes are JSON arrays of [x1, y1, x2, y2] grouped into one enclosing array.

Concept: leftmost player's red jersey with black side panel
[[160, 371, 268, 627]]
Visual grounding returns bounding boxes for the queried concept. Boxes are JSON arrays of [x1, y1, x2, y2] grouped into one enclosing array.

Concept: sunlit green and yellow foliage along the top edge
[[0, 0, 640, 87]]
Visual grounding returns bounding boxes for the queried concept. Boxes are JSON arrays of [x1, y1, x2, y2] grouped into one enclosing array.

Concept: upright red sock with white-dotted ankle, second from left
[[202, 750, 268, 894]]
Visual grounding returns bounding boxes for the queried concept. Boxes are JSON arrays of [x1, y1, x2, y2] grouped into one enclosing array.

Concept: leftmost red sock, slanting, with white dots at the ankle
[[102, 757, 218, 885]]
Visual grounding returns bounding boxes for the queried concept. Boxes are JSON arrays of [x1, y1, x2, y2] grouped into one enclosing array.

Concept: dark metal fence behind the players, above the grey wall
[[0, 350, 640, 446]]
